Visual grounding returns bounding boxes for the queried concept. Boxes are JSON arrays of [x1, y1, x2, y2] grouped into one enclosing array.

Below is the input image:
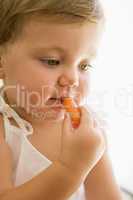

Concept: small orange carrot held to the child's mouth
[[63, 97, 80, 128]]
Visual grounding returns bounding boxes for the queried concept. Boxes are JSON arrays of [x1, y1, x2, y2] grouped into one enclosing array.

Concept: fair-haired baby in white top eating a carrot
[[0, 0, 122, 200]]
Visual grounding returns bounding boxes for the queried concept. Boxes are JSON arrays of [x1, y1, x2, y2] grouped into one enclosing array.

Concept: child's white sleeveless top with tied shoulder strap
[[0, 95, 85, 200]]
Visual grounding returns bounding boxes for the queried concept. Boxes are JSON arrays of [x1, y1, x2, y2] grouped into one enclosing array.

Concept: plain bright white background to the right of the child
[[90, 0, 133, 192]]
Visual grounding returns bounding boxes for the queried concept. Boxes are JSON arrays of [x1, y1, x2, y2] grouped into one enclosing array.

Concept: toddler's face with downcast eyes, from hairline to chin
[[1, 16, 100, 122]]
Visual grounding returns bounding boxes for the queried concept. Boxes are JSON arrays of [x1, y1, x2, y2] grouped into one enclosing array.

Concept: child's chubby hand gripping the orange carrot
[[59, 106, 105, 178]]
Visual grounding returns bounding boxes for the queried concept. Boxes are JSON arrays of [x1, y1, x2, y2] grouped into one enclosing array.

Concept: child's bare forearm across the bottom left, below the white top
[[0, 162, 82, 200]]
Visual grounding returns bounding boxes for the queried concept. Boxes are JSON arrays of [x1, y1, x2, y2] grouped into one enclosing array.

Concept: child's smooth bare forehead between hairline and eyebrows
[[16, 16, 101, 57]]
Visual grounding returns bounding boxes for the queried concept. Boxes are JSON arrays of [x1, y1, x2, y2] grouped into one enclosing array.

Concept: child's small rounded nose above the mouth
[[58, 67, 79, 87]]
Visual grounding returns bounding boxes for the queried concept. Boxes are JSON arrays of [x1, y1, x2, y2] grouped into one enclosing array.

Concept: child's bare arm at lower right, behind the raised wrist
[[84, 153, 122, 200]]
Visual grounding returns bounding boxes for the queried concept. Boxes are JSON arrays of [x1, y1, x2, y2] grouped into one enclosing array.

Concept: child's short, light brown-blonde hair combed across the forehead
[[0, 0, 104, 46]]
